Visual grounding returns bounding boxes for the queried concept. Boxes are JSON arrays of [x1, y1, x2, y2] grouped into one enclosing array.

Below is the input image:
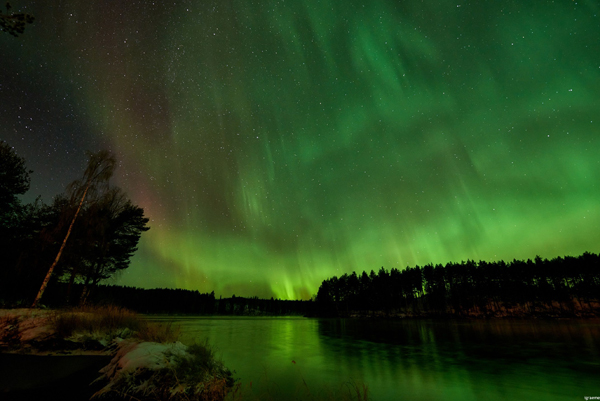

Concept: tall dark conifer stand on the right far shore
[[316, 252, 600, 317]]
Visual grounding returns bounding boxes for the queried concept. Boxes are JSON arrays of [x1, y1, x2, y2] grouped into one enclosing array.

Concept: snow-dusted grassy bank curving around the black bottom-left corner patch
[[0, 307, 234, 401]]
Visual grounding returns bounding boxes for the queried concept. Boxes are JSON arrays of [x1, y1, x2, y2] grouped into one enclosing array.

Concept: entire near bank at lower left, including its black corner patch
[[0, 307, 234, 400]]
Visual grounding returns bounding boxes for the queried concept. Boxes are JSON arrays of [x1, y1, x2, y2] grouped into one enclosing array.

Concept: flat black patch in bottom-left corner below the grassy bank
[[0, 354, 111, 401]]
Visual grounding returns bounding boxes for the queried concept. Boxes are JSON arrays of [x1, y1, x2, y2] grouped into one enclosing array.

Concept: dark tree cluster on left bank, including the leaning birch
[[0, 142, 149, 306]]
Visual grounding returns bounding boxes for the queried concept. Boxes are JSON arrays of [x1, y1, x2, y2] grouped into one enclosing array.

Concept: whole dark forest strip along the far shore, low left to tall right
[[23, 252, 600, 318]]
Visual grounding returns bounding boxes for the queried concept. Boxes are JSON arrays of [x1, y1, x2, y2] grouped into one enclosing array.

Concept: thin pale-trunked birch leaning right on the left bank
[[31, 150, 117, 308]]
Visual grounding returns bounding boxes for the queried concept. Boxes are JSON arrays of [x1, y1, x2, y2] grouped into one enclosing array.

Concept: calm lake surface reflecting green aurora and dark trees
[[149, 316, 600, 401]]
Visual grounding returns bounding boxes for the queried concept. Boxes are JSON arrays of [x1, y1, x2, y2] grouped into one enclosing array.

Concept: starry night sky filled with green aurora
[[0, 0, 600, 299]]
